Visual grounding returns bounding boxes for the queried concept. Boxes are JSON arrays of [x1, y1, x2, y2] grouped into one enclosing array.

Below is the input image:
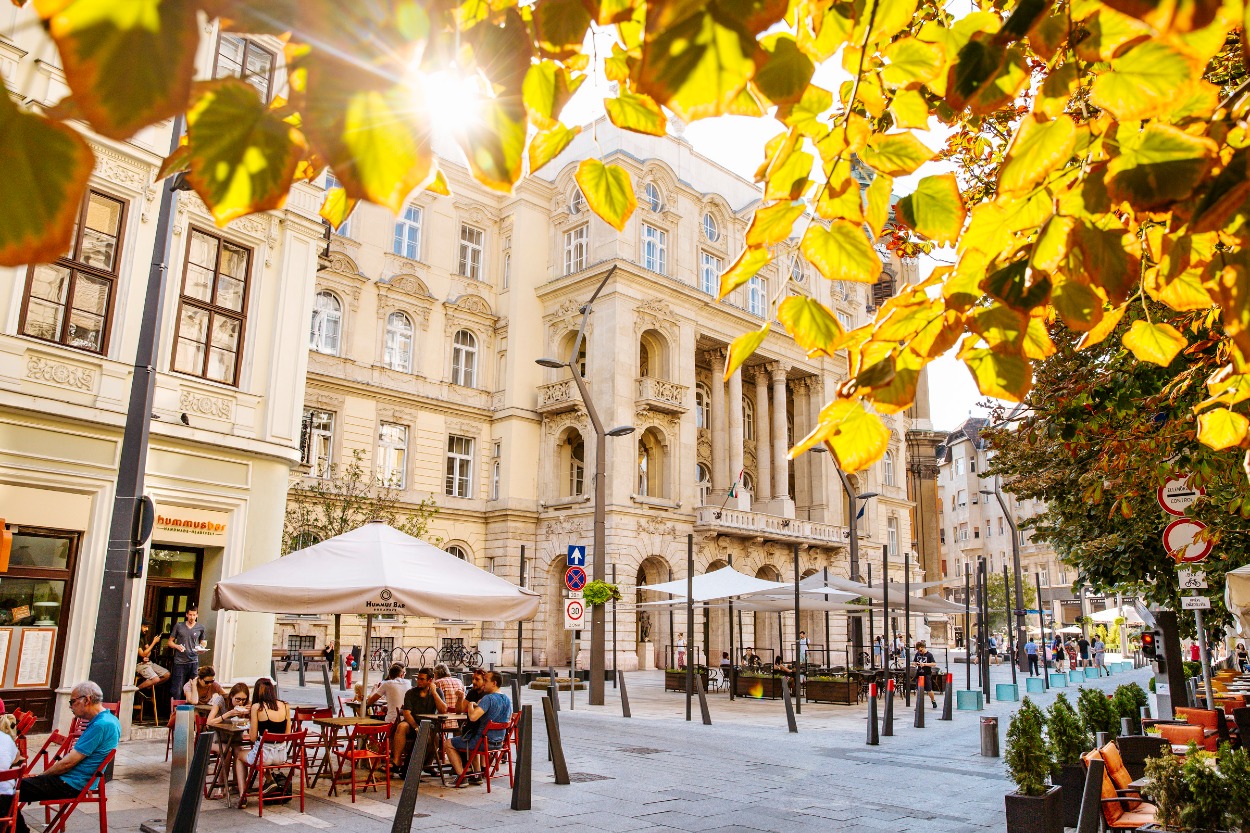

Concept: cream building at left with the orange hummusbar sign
[[0, 12, 325, 727]]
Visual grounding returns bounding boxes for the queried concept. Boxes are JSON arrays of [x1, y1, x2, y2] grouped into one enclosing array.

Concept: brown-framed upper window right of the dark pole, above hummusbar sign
[[173, 228, 251, 385]]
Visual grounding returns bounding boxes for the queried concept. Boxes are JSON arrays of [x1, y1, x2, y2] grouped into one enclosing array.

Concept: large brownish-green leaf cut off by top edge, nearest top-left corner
[[35, 0, 200, 139]]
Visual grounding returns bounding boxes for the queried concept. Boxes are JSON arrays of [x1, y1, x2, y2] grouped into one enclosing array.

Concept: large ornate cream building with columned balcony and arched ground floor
[[275, 121, 928, 669]]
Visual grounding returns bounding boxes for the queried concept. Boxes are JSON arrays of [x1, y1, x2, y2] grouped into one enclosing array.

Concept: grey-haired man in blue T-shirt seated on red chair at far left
[[15, 680, 121, 833]]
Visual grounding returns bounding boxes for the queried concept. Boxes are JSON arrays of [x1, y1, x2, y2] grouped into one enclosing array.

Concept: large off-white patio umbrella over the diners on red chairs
[[213, 522, 540, 690]]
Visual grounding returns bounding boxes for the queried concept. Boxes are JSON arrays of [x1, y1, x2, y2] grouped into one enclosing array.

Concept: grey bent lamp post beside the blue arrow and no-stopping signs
[[536, 266, 634, 705]]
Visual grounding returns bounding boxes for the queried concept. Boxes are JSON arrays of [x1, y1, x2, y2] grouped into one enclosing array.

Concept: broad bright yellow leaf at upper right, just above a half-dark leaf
[[1090, 40, 1198, 121]]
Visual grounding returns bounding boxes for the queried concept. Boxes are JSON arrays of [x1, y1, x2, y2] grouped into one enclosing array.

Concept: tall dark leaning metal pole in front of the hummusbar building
[[90, 116, 183, 703]]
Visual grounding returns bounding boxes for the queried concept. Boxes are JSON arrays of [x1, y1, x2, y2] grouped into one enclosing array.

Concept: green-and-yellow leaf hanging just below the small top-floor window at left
[[186, 78, 304, 226]]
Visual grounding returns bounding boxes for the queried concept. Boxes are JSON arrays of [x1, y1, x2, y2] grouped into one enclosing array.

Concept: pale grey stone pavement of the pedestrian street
[[46, 665, 1149, 833]]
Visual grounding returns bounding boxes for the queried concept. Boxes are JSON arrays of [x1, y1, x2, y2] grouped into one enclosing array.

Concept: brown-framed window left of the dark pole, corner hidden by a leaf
[[20, 191, 126, 353]]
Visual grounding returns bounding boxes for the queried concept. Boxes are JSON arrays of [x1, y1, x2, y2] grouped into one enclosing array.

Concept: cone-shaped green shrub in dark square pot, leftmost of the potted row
[[1003, 697, 1064, 833]]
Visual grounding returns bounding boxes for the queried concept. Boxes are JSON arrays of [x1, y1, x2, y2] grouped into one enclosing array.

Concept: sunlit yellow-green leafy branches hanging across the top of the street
[[7, 0, 1250, 470]]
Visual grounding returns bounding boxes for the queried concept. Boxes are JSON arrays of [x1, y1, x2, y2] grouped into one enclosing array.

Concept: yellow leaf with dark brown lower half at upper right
[[1106, 123, 1216, 210]]
